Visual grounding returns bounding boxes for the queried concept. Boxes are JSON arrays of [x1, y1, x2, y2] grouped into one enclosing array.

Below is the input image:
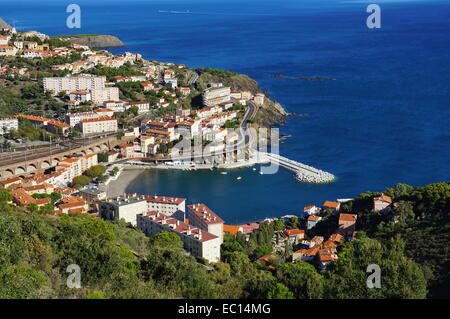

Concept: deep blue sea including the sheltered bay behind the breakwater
[[0, 0, 450, 223]]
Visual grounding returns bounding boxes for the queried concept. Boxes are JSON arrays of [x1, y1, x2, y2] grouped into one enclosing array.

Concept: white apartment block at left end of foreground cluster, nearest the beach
[[100, 196, 147, 226]]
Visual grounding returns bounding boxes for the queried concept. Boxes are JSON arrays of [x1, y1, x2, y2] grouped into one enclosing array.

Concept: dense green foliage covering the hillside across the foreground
[[0, 183, 450, 299]]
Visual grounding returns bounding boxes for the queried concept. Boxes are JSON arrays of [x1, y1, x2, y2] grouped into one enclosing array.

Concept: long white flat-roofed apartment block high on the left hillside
[[44, 76, 107, 94]]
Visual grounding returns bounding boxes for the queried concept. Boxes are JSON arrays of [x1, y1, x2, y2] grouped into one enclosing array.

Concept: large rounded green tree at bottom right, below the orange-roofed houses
[[324, 236, 427, 299]]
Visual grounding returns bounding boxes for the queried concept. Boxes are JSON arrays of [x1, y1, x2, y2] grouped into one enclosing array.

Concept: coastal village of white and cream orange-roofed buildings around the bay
[[0, 23, 384, 269]]
